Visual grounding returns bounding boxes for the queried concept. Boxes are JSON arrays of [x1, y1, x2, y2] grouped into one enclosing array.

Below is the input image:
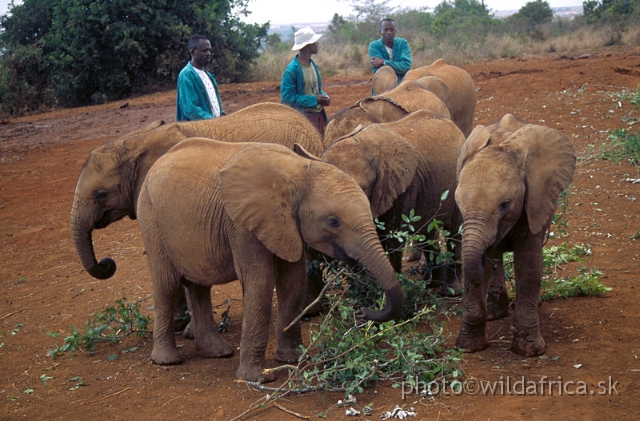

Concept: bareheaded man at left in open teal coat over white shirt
[[176, 35, 225, 121]]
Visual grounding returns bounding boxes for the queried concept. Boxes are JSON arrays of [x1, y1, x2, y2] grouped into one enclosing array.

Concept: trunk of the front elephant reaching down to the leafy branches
[[353, 231, 404, 322]]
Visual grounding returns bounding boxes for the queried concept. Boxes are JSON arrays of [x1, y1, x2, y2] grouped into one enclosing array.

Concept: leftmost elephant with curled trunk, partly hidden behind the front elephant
[[70, 102, 324, 279]]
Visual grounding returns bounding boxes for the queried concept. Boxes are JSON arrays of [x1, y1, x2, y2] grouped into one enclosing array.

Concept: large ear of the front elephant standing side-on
[[218, 144, 309, 262]]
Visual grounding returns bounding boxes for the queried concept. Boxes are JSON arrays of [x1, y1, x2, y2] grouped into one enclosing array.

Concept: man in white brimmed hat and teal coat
[[280, 26, 330, 135]]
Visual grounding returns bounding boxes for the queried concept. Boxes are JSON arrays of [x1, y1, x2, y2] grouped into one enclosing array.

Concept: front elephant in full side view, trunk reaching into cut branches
[[138, 138, 403, 382]]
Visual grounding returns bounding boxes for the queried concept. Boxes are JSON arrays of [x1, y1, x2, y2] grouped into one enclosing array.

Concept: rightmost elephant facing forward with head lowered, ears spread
[[455, 115, 576, 357]]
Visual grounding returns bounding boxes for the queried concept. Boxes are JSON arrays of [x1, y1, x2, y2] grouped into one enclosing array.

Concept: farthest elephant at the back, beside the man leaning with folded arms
[[403, 59, 478, 137]]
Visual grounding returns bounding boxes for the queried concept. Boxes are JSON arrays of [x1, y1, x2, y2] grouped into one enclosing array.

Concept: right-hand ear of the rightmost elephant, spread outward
[[500, 124, 576, 234]]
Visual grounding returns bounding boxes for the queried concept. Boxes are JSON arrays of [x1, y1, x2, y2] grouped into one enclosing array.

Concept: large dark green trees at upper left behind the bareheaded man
[[0, 0, 269, 112]]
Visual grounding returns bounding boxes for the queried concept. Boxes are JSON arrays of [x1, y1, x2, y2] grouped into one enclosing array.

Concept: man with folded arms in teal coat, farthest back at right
[[369, 18, 412, 83]]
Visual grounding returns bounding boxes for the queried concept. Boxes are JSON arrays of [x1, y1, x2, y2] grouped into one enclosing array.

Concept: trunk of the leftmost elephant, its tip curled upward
[[70, 196, 116, 279]]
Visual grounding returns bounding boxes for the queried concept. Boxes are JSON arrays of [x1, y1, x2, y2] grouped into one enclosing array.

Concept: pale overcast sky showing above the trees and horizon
[[0, 0, 582, 25]]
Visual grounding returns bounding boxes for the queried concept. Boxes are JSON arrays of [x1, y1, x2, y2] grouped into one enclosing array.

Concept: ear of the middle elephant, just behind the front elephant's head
[[362, 126, 420, 217]]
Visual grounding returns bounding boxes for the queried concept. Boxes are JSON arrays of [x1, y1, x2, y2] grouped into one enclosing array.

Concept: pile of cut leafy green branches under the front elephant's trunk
[[261, 262, 462, 395]]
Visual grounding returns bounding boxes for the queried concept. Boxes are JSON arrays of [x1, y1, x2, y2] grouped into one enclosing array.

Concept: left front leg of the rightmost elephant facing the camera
[[456, 263, 492, 352]]
